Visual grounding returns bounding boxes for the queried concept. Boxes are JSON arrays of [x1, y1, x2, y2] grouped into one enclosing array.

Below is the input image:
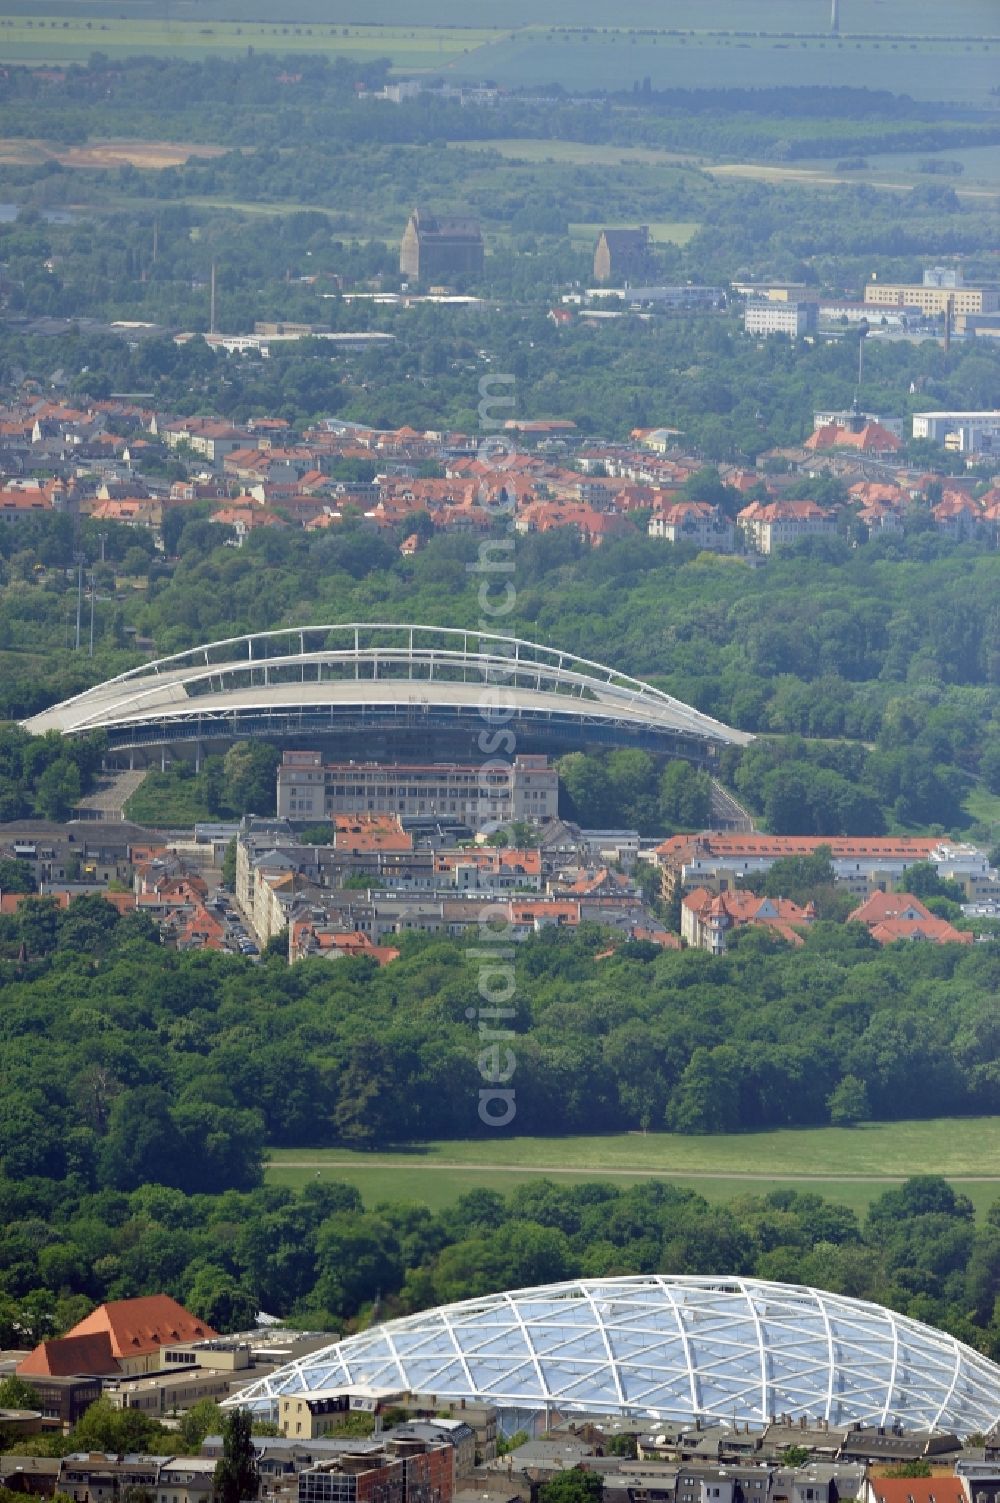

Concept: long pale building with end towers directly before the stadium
[[278, 752, 559, 830]]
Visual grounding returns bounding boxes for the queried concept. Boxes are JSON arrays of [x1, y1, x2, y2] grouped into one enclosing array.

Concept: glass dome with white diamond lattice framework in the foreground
[[227, 1275, 1000, 1435]]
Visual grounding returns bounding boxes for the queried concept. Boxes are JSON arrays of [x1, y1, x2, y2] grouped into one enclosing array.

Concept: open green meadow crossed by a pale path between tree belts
[[268, 1117, 1000, 1214]]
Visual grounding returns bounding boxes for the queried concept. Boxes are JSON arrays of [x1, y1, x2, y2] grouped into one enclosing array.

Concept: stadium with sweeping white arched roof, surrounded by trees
[[24, 622, 753, 750]]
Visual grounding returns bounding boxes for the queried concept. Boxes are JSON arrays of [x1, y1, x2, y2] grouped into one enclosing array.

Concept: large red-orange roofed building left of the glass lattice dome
[[17, 1294, 218, 1377]]
